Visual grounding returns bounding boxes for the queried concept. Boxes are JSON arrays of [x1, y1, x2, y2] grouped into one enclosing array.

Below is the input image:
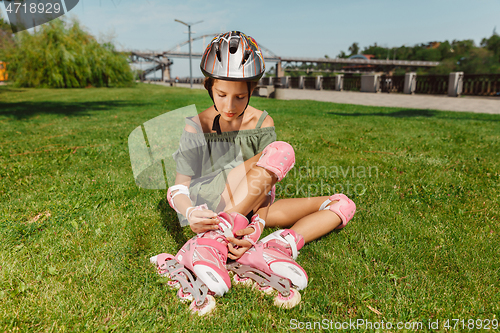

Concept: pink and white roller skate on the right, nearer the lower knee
[[227, 229, 308, 309]]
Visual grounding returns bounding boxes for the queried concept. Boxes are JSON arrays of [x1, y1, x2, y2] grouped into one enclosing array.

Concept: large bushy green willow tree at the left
[[7, 19, 133, 88]]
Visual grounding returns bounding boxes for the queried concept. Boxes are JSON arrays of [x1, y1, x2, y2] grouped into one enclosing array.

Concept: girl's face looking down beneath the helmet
[[212, 80, 249, 121]]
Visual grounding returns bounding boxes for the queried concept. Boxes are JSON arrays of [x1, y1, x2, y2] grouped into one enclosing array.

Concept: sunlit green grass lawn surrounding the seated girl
[[0, 85, 500, 332]]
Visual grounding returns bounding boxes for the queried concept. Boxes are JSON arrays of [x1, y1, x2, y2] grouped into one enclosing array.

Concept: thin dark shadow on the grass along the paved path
[[327, 109, 500, 122]]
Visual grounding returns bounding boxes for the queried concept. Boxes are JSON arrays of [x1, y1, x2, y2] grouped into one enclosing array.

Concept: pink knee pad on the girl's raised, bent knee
[[257, 141, 295, 181]]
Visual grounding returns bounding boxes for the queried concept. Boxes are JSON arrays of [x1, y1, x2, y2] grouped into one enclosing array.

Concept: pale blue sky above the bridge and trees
[[0, 0, 500, 76]]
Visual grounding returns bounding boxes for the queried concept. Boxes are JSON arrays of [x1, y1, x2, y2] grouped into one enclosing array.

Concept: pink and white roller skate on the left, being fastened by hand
[[150, 212, 248, 316]]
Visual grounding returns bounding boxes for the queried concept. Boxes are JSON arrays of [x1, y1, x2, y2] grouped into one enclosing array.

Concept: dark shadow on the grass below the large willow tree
[[0, 101, 144, 120]]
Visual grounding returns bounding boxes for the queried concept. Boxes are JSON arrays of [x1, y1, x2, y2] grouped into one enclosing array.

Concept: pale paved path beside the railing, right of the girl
[[275, 89, 500, 114]]
